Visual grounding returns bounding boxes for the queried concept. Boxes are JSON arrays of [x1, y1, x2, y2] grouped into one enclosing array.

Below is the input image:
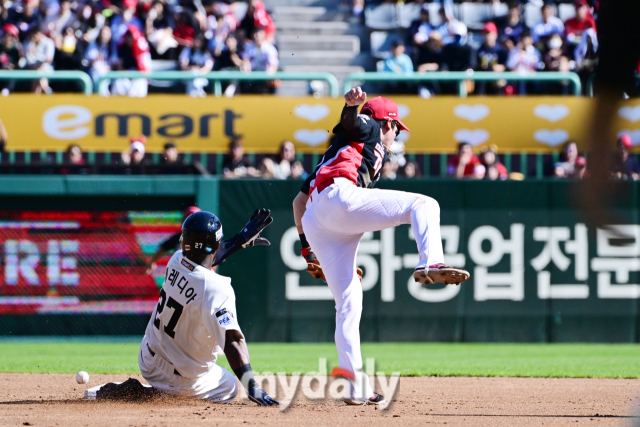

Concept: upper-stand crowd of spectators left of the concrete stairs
[[0, 0, 278, 96]]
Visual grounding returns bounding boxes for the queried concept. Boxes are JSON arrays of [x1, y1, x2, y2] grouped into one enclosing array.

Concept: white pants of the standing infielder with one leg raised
[[302, 178, 444, 400]]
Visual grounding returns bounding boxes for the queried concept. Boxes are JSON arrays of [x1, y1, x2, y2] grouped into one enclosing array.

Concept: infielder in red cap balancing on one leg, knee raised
[[293, 87, 469, 405]]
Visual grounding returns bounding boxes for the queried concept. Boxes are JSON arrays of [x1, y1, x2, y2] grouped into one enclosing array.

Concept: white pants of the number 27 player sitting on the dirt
[[138, 339, 238, 403]]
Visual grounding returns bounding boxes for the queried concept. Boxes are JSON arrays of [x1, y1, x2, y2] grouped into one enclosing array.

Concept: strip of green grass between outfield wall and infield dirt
[[0, 340, 640, 378]]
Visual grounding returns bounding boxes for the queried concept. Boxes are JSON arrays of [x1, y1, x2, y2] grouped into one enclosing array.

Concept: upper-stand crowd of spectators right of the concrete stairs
[[382, 0, 598, 96]]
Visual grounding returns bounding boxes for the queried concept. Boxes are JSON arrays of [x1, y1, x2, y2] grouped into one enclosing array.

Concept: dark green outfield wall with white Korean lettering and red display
[[0, 177, 640, 342]]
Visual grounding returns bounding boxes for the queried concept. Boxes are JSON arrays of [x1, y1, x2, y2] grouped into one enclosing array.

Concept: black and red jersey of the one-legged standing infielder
[[300, 106, 388, 195]]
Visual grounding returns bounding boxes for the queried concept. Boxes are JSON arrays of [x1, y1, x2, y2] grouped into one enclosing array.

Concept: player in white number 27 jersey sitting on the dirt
[[138, 209, 278, 406]]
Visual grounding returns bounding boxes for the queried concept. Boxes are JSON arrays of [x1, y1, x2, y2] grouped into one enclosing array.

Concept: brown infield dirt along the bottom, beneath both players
[[0, 374, 640, 427]]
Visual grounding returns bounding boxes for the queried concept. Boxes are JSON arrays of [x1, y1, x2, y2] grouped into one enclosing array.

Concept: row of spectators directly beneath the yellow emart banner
[[0, 134, 640, 181]]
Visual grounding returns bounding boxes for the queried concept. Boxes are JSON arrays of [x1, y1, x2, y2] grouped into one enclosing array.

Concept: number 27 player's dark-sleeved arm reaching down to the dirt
[[224, 329, 280, 406]]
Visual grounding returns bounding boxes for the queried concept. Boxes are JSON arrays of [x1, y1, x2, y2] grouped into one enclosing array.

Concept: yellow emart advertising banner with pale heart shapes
[[0, 94, 640, 153]]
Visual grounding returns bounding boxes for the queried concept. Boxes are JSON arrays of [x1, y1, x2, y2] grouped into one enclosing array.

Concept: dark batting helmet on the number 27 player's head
[[180, 211, 223, 255]]
